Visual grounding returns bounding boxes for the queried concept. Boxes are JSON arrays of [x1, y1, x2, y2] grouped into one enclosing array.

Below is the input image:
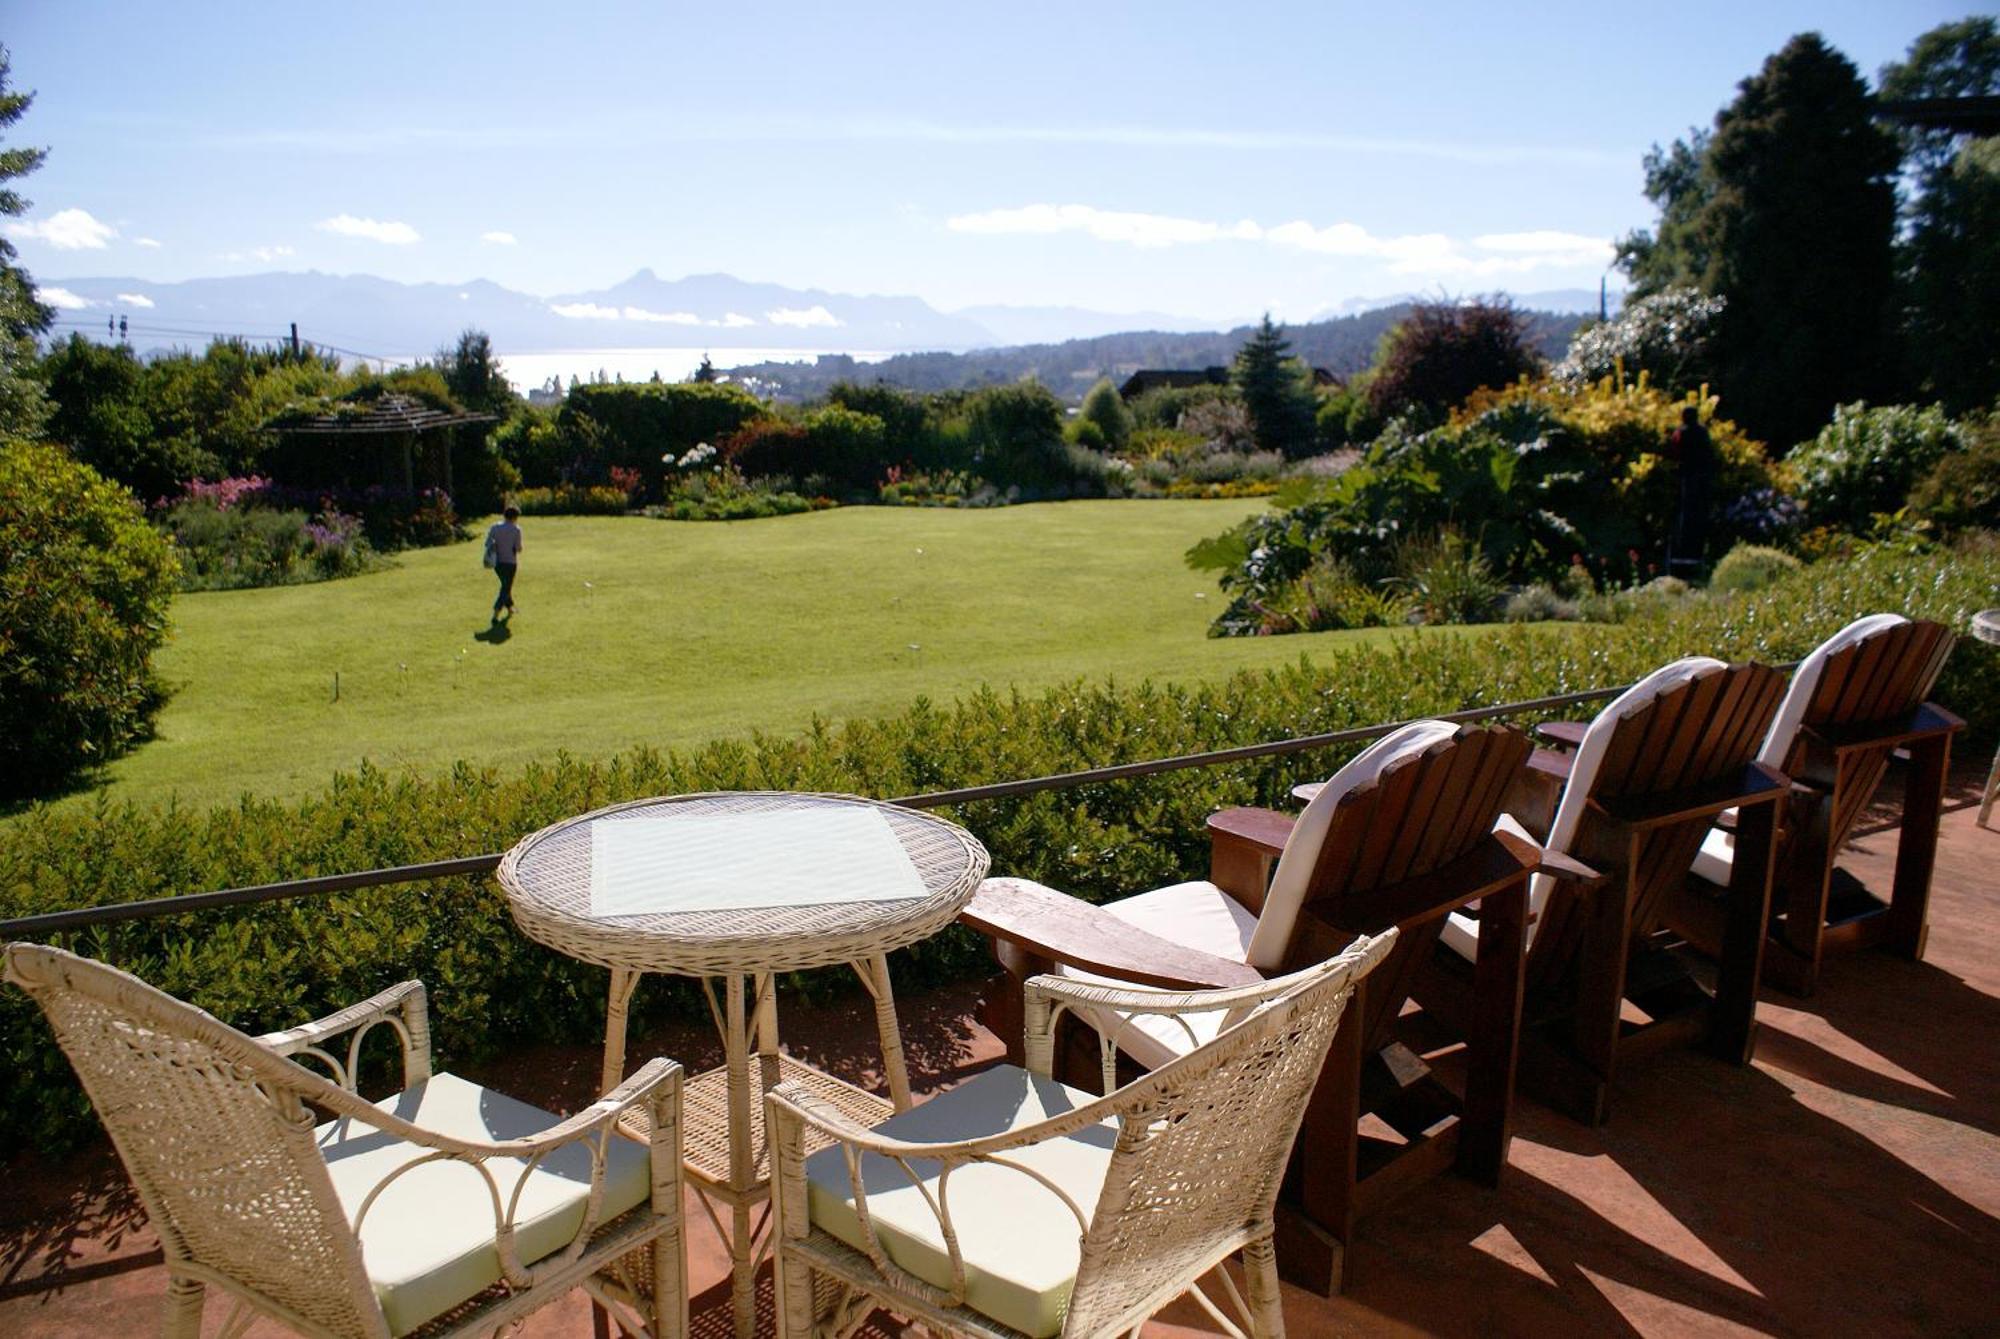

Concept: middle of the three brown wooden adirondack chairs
[[1414, 658, 1786, 1125]]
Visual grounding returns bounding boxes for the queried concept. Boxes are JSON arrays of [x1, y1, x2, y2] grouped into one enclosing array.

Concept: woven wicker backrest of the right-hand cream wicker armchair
[[1064, 935, 1394, 1335]]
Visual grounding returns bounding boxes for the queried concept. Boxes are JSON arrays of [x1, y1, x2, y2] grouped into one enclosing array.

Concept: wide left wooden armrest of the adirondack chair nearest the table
[[958, 879, 1264, 989]]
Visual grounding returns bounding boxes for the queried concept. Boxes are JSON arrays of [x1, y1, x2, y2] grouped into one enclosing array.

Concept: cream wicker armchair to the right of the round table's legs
[[766, 931, 1396, 1339]]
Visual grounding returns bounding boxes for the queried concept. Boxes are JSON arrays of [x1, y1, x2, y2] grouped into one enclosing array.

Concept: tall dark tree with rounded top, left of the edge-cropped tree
[[1620, 32, 1898, 446]]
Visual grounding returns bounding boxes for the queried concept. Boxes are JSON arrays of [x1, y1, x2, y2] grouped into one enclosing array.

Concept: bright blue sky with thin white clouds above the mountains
[[0, 0, 1974, 320]]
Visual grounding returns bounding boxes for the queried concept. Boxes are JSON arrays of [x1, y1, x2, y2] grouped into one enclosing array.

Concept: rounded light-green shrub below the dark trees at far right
[[1786, 402, 1964, 532]]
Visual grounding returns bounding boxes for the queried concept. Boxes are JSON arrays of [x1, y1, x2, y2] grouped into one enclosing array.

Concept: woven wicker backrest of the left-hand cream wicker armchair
[[6, 943, 388, 1339]]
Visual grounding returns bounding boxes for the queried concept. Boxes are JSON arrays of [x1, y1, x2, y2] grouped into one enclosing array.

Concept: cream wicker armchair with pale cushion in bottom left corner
[[6, 943, 688, 1339]]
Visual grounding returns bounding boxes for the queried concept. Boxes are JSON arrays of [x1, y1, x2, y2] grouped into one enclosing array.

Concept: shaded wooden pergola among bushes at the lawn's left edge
[[264, 392, 498, 494]]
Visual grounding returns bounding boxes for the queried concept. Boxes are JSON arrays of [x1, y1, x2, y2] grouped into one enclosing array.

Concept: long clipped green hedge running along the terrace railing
[[0, 552, 2000, 1151]]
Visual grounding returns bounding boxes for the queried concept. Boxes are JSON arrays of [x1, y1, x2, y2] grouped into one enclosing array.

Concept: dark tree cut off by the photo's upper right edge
[[1880, 18, 2000, 410]]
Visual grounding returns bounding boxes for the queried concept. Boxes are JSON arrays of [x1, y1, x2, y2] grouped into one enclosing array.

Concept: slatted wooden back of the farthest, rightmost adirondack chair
[[1766, 620, 1956, 851]]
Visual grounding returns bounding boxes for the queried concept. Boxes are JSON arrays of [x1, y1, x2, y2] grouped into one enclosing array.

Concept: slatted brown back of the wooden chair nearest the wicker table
[[1286, 725, 1534, 1051]]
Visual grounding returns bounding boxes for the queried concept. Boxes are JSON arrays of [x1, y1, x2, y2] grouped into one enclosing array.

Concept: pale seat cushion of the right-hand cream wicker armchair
[[806, 1065, 1118, 1339]]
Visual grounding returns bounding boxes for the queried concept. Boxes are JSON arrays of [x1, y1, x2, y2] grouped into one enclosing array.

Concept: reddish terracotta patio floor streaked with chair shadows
[[0, 771, 2000, 1339]]
